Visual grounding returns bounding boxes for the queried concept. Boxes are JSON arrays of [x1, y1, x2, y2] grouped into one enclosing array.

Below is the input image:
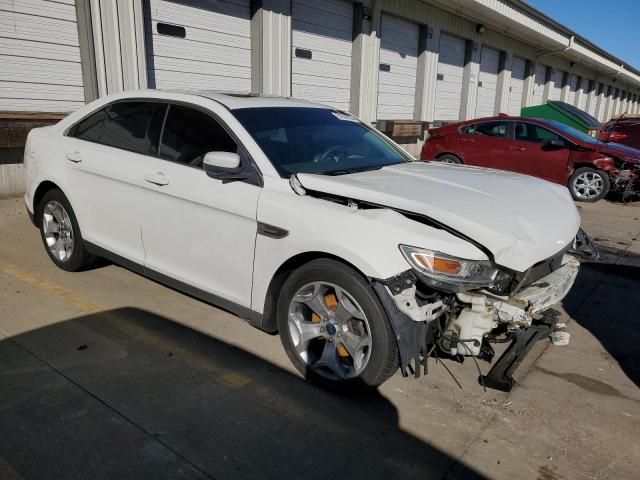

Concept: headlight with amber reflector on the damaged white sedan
[[400, 245, 511, 292]]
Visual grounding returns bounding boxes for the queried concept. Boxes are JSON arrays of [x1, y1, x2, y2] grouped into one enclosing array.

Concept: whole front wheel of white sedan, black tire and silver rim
[[277, 259, 398, 387]]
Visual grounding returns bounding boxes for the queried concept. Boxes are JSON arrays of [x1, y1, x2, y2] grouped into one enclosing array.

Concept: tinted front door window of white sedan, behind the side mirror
[[160, 105, 238, 167]]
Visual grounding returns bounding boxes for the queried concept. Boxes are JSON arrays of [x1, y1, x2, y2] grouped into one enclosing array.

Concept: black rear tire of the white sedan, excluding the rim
[[36, 189, 95, 272]]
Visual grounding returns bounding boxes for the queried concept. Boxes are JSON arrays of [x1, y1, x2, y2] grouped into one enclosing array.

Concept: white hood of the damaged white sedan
[[297, 162, 580, 272]]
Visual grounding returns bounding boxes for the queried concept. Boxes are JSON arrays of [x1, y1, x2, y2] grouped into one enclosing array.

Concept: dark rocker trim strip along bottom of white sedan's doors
[[84, 241, 262, 330]]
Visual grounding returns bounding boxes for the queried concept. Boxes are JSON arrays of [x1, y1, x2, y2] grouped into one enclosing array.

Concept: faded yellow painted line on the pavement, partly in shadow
[[0, 258, 251, 388]]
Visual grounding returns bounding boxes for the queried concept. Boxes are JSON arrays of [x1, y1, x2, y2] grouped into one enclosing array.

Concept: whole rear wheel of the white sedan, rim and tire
[[37, 189, 93, 272]]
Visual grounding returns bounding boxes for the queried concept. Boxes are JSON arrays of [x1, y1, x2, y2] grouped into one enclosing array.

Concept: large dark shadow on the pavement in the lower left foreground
[[0, 308, 484, 480]]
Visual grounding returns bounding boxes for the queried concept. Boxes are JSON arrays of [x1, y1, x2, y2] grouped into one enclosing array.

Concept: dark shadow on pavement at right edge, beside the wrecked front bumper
[[564, 253, 640, 387]]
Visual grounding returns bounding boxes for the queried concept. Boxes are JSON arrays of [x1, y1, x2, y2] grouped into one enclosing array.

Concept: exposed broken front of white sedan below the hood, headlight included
[[372, 235, 597, 391]]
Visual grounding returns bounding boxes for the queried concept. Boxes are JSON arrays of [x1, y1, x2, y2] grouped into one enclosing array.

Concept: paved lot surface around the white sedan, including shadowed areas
[[0, 198, 640, 480]]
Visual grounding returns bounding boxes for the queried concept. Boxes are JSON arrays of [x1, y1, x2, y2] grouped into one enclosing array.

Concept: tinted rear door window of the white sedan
[[100, 101, 166, 155]]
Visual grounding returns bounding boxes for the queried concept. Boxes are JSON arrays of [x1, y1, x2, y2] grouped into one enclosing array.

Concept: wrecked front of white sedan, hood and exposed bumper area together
[[292, 164, 598, 391]]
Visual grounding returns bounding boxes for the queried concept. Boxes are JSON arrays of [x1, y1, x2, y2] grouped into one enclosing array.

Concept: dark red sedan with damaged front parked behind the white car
[[420, 115, 640, 202]]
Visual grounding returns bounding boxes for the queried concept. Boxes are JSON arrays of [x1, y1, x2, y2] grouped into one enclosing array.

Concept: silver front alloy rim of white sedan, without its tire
[[288, 281, 372, 380]]
